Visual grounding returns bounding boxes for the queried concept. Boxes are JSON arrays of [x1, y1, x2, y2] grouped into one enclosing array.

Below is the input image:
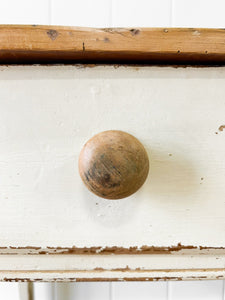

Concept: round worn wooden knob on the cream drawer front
[[79, 130, 149, 199]]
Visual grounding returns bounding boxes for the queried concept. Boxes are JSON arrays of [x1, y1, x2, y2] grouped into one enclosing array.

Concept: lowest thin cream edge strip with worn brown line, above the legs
[[0, 269, 225, 282]]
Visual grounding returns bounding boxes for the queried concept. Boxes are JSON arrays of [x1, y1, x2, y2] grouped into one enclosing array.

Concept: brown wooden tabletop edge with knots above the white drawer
[[0, 25, 225, 64]]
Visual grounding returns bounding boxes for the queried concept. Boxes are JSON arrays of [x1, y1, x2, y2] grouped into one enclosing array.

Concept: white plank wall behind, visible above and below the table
[[0, 0, 225, 300]]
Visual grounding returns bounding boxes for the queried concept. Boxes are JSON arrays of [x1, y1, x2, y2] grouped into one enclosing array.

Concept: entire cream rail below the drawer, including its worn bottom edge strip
[[0, 255, 225, 281]]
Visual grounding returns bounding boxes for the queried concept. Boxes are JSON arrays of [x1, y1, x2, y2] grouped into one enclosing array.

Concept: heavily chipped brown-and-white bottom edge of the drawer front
[[0, 243, 225, 255]]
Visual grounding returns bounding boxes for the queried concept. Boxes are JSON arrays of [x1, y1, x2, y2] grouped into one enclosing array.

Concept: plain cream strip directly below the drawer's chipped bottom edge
[[0, 254, 225, 274]]
